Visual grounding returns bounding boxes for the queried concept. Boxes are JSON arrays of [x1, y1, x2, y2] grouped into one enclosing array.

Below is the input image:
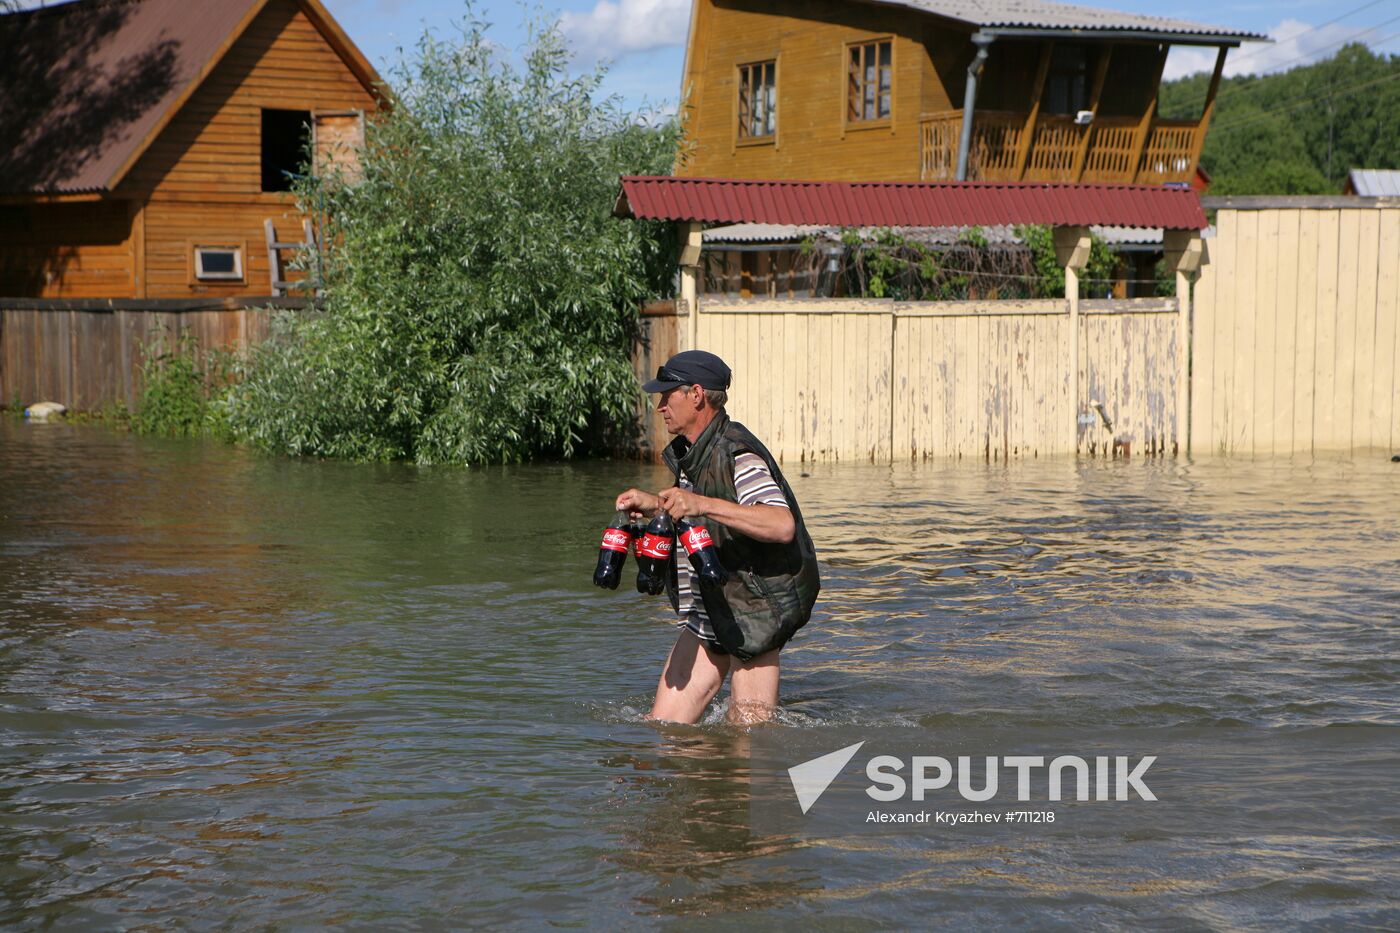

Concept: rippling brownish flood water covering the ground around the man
[[0, 419, 1400, 932]]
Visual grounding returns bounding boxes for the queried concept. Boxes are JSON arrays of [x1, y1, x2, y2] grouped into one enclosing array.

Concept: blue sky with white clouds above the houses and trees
[[323, 0, 1400, 109]]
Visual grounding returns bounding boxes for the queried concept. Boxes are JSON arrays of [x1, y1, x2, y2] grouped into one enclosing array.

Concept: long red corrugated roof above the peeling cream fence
[[613, 175, 1205, 230]]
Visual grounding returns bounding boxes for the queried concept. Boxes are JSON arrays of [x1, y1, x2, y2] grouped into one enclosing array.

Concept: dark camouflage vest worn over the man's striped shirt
[[662, 412, 822, 661]]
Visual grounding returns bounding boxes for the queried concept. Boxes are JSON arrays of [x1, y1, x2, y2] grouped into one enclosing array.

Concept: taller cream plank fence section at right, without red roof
[[1191, 198, 1400, 454]]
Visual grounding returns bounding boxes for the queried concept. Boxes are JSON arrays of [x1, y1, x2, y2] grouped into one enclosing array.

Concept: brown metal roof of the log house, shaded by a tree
[[0, 0, 378, 193]]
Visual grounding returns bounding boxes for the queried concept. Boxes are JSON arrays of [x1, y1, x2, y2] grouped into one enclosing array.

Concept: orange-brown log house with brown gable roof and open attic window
[[0, 0, 384, 295]]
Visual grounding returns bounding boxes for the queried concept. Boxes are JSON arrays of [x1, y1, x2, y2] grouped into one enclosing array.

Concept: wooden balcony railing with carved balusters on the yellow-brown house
[[920, 111, 1201, 185]]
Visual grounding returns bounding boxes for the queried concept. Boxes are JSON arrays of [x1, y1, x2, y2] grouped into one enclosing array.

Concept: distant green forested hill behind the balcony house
[[1162, 43, 1400, 195]]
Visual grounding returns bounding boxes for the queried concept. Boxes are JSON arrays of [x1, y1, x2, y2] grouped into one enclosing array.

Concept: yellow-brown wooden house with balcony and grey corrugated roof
[[676, 0, 1264, 185]]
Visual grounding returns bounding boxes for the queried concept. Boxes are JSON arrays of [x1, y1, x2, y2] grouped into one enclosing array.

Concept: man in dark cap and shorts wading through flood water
[[616, 350, 820, 723]]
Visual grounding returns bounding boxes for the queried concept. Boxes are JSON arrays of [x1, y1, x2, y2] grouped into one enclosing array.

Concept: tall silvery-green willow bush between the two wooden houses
[[228, 22, 676, 464]]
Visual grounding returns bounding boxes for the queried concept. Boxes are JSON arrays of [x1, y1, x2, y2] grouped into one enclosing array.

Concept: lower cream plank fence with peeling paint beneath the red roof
[[647, 298, 1180, 462]]
